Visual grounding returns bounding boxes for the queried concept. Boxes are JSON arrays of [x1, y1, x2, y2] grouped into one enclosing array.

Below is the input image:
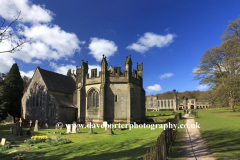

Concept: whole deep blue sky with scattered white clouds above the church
[[0, 0, 240, 95]]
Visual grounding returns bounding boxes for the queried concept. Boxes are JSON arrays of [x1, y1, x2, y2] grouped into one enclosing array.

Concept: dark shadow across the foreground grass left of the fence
[[1, 140, 158, 160]]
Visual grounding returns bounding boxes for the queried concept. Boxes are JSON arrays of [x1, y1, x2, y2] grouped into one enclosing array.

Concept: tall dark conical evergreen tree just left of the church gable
[[4, 63, 24, 122]]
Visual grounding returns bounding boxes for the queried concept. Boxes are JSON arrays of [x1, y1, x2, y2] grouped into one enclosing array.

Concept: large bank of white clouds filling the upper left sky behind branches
[[0, 0, 85, 72]]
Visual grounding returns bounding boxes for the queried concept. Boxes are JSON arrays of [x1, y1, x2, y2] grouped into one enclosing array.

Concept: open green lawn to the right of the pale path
[[195, 107, 240, 159]]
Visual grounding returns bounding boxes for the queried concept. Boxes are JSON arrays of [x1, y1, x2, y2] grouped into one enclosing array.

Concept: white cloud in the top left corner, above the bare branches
[[0, 0, 53, 23]]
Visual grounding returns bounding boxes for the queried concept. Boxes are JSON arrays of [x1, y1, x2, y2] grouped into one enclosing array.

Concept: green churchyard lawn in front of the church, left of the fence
[[0, 111, 180, 160]]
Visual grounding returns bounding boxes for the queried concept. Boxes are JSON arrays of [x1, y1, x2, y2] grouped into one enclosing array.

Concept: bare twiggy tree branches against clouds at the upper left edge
[[0, 11, 30, 53]]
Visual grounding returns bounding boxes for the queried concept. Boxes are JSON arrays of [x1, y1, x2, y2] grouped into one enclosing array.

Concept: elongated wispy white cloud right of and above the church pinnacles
[[127, 32, 176, 53]]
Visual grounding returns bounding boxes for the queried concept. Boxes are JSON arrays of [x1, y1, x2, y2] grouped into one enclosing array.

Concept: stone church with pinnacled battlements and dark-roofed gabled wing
[[22, 55, 145, 125]]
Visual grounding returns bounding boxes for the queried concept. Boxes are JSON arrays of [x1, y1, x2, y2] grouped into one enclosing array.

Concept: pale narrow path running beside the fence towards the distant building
[[184, 114, 215, 160]]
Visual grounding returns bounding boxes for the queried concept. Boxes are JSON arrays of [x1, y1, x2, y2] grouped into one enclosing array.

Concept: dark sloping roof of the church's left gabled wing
[[38, 67, 76, 94]]
